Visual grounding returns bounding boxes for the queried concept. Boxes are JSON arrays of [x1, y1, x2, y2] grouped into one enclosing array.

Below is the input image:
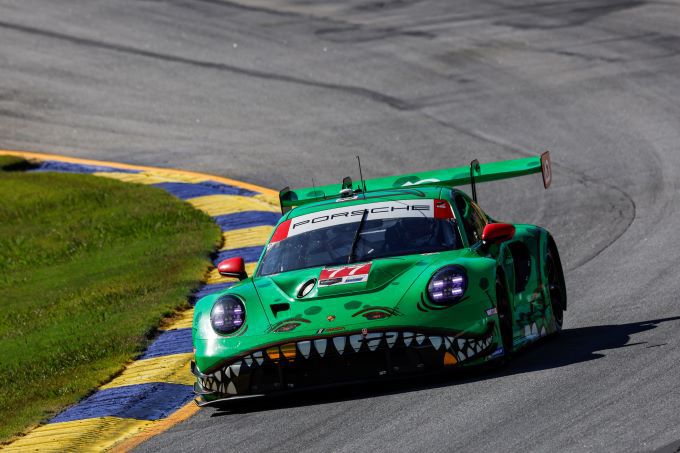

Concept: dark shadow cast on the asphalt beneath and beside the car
[[211, 316, 680, 417]]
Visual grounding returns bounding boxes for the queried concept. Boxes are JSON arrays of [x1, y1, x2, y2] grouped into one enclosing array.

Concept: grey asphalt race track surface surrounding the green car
[[0, 0, 680, 451]]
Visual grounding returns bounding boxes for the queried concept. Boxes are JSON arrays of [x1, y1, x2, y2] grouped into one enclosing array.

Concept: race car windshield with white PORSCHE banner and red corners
[[258, 200, 461, 276]]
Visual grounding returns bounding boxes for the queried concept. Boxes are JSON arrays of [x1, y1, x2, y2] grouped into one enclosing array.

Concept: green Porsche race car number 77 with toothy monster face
[[191, 152, 567, 405]]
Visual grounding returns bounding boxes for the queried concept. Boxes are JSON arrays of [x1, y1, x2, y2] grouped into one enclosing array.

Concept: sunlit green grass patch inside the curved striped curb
[[0, 156, 220, 441]]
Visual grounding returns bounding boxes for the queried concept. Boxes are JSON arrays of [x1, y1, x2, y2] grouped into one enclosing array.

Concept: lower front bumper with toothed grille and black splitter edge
[[191, 322, 501, 405]]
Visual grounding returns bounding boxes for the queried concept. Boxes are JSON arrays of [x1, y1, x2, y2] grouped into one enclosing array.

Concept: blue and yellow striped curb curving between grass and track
[[0, 150, 281, 451]]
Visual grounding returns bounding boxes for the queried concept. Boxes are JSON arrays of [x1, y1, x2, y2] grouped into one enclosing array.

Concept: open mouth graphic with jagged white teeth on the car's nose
[[197, 323, 497, 397]]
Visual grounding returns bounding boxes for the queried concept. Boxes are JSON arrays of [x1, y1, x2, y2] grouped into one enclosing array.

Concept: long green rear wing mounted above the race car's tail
[[279, 151, 552, 213]]
